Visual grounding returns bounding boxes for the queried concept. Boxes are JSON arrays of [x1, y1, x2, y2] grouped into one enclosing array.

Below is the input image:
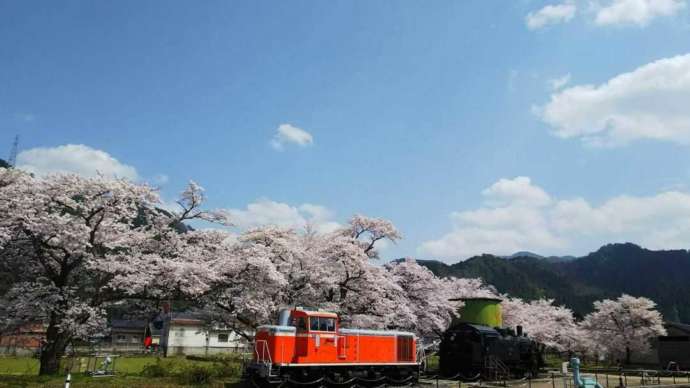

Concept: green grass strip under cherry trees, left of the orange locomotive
[[0, 356, 241, 388]]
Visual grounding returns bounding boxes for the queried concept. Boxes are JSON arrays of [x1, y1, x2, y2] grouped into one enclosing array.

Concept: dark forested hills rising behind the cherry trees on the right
[[418, 243, 690, 322]]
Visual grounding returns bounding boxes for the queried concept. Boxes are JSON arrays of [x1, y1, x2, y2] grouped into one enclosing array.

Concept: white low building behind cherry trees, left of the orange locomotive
[[160, 314, 249, 356]]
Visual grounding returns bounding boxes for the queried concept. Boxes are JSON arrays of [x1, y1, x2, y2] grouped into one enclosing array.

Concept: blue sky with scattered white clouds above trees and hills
[[0, 0, 690, 261]]
